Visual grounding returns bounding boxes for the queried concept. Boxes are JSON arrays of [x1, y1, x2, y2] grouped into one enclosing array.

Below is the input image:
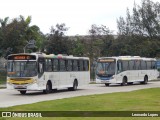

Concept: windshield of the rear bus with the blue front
[[96, 61, 116, 76]]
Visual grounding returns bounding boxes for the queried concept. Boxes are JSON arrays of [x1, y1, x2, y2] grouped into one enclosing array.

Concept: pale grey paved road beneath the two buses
[[0, 81, 160, 107]]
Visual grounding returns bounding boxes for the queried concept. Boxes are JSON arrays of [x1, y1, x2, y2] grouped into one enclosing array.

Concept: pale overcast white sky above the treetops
[[0, 0, 160, 35]]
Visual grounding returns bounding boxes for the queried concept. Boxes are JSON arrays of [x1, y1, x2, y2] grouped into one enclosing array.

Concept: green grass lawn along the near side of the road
[[0, 88, 160, 120]]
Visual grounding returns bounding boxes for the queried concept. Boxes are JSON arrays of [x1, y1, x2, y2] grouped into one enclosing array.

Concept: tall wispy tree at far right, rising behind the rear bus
[[116, 0, 160, 57]]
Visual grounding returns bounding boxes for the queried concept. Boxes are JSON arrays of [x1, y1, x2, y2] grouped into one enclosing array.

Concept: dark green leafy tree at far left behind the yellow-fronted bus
[[0, 15, 43, 57]]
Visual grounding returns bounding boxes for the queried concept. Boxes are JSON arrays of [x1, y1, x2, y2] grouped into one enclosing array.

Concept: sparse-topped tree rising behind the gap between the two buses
[[89, 25, 114, 60]]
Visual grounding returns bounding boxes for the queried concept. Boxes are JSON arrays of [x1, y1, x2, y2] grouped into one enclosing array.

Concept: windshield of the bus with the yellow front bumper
[[7, 61, 37, 77]]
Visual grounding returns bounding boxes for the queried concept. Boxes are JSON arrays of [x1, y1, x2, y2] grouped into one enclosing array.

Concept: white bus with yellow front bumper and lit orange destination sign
[[7, 53, 90, 94]]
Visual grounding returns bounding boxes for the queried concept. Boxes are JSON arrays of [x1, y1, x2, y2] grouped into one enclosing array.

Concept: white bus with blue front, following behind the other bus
[[96, 56, 158, 86]]
